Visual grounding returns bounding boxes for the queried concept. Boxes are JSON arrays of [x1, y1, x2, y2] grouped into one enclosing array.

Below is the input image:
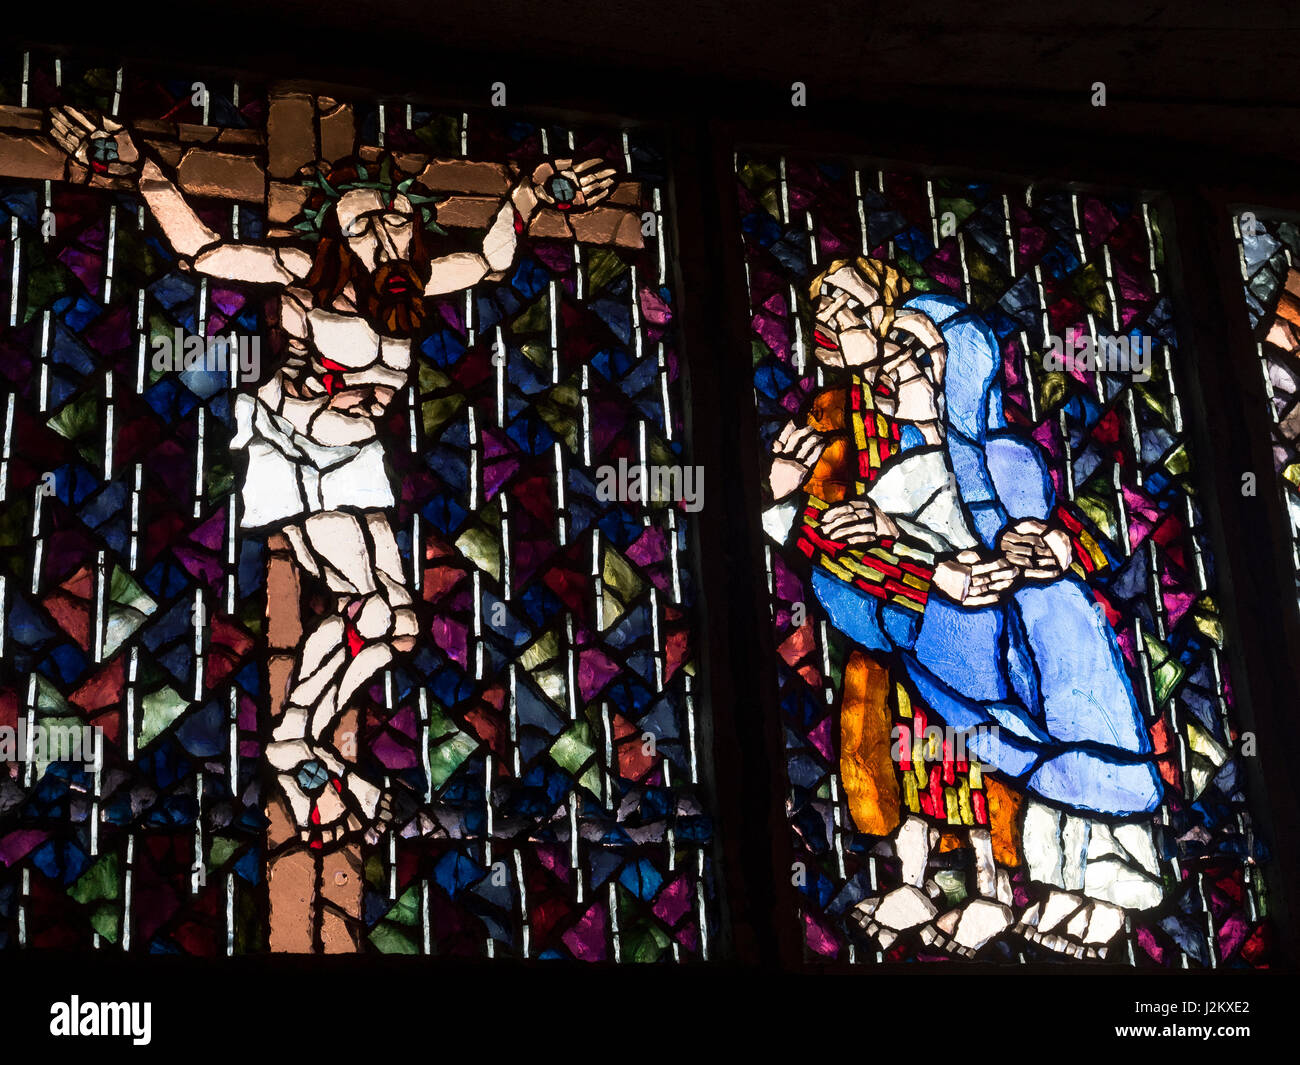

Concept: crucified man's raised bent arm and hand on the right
[[424, 159, 614, 295]]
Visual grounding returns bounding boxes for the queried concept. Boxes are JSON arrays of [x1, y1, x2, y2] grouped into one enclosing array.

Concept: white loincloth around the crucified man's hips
[[230, 393, 397, 529]]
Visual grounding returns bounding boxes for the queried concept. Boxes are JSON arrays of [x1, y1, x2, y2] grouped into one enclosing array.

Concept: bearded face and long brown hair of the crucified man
[[307, 189, 429, 338]]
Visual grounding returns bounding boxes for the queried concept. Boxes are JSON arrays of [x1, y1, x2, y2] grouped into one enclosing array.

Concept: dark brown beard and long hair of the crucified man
[[306, 226, 429, 339]]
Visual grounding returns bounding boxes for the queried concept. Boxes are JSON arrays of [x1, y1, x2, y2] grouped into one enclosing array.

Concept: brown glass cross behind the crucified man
[[0, 87, 644, 953]]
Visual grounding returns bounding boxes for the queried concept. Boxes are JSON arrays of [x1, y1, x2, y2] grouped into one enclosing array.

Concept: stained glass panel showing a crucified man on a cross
[[0, 52, 716, 961]]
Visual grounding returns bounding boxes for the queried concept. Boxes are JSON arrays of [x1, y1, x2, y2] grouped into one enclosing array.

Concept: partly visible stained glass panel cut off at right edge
[[1234, 211, 1300, 608]]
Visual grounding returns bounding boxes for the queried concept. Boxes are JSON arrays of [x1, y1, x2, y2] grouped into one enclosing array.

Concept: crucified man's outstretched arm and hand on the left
[[49, 107, 311, 285]]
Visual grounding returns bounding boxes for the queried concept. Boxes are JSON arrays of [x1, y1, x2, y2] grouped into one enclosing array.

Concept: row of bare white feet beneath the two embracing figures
[[849, 884, 1125, 961]]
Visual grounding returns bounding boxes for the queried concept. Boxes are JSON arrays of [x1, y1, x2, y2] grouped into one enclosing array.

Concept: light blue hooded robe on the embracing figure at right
[[813, 295, 1161, 817]]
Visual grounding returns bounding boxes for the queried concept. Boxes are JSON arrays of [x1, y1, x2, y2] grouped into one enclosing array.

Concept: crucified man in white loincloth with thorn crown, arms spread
[[51, 100, 615, 848]]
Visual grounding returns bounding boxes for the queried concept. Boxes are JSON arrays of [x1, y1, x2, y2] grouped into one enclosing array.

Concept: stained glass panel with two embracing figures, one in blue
[[736, 152, 1270, 969]]
